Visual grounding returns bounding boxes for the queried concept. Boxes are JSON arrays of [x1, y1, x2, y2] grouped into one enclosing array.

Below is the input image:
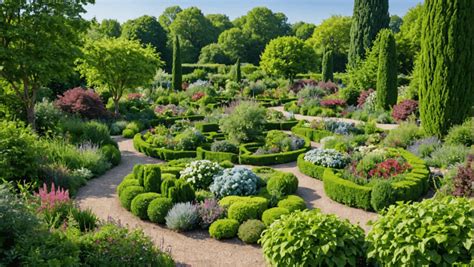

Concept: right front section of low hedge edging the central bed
[[239, 138, 311, 166]]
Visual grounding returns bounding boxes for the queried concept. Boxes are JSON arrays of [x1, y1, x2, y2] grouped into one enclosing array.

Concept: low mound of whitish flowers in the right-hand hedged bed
[[304, 148, 349, 169]]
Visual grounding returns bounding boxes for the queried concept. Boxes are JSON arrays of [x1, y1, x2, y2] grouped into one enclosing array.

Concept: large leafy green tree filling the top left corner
[[0, 0, 93, 128]]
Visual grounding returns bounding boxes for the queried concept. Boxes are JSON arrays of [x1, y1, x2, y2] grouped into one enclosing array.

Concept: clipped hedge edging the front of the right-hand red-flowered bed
[[323, 149, 429, 210]]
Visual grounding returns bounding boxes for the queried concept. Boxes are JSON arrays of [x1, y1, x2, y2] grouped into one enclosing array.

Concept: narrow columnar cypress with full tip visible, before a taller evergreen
[[377, 29, 398, 110]]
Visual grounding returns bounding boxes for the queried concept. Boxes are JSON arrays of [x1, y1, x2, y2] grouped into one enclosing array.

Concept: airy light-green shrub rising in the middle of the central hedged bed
[[219, 102, 266, 143]]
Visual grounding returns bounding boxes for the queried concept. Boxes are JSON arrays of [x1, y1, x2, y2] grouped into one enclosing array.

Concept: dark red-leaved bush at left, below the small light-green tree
[[55, 87, 109, 119]]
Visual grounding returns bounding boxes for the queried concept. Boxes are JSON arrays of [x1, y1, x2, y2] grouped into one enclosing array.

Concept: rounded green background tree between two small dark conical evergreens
[[260, 36, 316, 82]]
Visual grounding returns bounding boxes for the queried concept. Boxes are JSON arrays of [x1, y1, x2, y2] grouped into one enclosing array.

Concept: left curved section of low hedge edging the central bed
[[133, 133, 196, 161]]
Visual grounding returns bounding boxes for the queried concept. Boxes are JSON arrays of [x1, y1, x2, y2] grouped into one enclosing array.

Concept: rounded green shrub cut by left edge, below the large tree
[[0, 120, 40, 181]]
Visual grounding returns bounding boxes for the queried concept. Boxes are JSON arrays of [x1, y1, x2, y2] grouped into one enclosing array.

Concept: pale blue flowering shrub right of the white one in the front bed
[[210, 167, 258, 198]]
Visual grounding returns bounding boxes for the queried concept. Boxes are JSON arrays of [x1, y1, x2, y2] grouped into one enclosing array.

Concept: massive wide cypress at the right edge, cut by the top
[[418, 0, 474, 137]]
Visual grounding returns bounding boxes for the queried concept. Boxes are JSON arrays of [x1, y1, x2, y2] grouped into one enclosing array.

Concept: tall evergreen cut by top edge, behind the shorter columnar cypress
[[349, 0, 390, 66]]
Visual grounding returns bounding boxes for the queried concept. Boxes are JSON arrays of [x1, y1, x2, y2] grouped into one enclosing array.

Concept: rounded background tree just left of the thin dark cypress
[[122, 15, 171, 68]]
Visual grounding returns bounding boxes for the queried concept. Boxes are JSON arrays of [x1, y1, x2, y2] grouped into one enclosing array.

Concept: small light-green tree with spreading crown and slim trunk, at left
[[77, 38, 162, 115]]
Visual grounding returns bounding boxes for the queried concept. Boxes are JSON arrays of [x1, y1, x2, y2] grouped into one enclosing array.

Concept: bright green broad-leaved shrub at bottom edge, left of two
[[260, 210, 365, 266]]
